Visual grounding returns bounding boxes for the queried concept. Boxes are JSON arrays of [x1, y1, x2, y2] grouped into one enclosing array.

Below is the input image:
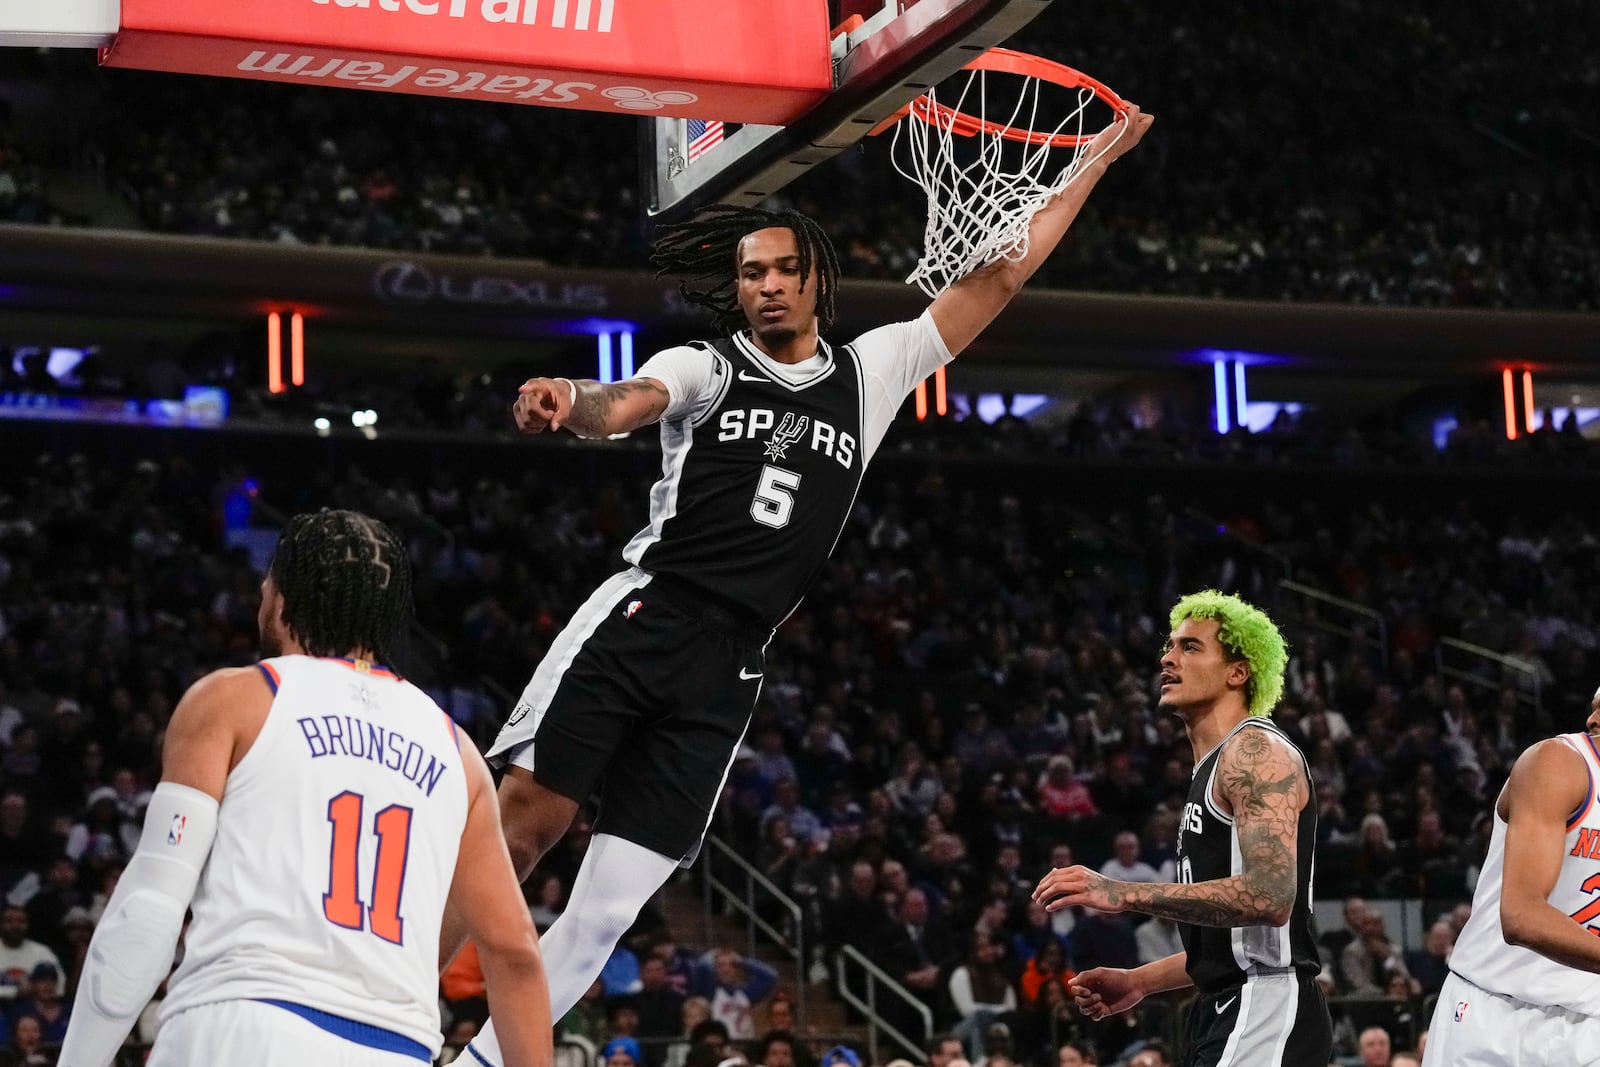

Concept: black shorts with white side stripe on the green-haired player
[[1179, 971, 1333, 1067]]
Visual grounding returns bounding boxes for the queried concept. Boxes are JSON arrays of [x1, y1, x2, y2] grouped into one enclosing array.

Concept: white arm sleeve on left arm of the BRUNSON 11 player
[[58, 782, 218, 1067]]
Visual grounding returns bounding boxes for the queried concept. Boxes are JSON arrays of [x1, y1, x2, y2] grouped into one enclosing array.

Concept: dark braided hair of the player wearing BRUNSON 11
[[269, 509, 411, 662]]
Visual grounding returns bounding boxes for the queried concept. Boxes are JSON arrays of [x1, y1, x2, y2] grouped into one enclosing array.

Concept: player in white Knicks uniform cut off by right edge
[[1422, 689, 1600, 1067]]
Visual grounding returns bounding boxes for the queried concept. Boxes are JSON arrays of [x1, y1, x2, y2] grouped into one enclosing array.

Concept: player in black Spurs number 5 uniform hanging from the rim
[[440, 109, 1152, 1067]]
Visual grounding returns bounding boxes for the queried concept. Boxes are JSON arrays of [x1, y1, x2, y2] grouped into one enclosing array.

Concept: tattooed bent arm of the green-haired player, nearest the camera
[[1034, 729, 1310, 926]]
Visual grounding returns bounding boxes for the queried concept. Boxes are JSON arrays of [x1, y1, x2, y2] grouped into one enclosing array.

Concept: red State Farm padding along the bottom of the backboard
[[101, 0, 832, 125]]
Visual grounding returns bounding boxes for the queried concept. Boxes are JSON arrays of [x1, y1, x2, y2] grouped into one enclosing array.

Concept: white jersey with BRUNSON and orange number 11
[[160, 656, 467, 1056]]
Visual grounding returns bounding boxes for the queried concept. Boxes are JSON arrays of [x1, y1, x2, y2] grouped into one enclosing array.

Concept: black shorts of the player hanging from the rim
[[488, 568, 766, 865]]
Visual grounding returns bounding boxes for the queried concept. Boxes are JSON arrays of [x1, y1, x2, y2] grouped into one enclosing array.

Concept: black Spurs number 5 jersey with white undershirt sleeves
[[622, 315, 949, 630]]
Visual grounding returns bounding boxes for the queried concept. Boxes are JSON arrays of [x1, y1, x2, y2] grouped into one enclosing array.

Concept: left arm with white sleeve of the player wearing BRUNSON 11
[[58, 667, 262, 1067]]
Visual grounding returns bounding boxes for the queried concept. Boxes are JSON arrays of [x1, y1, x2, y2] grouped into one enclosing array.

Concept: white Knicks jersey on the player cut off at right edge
[[1450, 734, 1600, 1016]]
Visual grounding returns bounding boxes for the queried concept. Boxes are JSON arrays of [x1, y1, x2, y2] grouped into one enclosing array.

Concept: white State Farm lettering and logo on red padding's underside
[[235, 53, 699, 112]]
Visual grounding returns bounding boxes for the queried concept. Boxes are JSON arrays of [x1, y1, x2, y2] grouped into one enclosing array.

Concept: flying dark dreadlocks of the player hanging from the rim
[[651, 203, 838, 334]]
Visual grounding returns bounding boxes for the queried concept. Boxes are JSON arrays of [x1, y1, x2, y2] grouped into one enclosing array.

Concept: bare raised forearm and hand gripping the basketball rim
[[933, 104, 1155, 355]]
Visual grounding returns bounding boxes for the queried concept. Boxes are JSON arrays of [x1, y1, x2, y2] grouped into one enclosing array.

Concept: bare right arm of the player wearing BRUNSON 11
[[450, 739, 555, 1067]]
